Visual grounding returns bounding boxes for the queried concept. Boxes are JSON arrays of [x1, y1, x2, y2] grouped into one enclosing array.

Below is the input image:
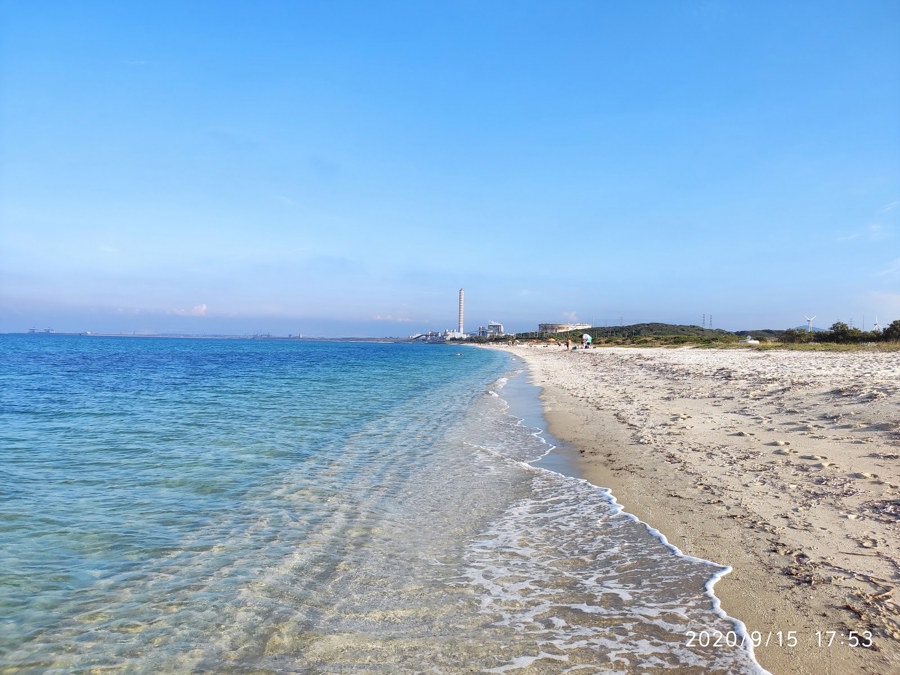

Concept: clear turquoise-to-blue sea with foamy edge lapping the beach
[[0, 334, 764, 673]]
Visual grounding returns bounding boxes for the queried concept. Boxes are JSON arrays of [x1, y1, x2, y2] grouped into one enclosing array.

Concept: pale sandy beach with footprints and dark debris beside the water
[[500, 346, 900, 674]]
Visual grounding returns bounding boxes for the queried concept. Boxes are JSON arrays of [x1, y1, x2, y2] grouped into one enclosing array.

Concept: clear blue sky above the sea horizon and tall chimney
[[0, 0, 900, 336]]
